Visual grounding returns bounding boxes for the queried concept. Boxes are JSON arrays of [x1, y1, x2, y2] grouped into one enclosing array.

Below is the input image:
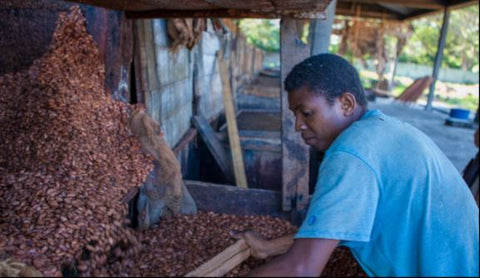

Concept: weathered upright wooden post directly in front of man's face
[[280, 19, 310, 211]]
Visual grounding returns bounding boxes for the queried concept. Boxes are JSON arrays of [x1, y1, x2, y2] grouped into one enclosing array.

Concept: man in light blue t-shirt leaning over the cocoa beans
[[234, 54, 479, 277]]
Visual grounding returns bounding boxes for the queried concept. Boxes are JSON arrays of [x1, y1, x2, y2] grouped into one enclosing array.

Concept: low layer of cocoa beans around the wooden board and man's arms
[[122, 212, 366, 277]]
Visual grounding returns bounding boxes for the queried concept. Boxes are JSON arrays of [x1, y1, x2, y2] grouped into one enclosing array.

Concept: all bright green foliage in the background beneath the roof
[[239, 4, 479, 74]]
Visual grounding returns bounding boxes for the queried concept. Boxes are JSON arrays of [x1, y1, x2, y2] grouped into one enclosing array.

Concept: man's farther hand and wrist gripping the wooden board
[[230, 230, 293, 259]]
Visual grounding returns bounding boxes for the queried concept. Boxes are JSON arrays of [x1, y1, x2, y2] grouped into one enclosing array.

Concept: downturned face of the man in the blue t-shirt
[[288, 86, 349, 151]]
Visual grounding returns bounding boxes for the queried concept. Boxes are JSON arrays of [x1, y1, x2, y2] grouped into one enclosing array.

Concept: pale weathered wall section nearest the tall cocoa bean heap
[[135, 19, 193, 147]]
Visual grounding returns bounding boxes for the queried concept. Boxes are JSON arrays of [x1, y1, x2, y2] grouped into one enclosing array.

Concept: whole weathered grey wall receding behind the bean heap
[[134, 19, 263, 147]]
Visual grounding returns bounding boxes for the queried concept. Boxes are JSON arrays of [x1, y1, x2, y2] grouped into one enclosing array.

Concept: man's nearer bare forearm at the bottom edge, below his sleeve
[[247, 237, 339, 277]]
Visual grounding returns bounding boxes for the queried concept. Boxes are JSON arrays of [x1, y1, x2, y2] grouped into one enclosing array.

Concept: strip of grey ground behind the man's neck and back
[[368, 98, 478, 172]]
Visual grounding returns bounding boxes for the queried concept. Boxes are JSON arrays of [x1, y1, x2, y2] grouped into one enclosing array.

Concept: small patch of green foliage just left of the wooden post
[[240, 19, 280, 52]]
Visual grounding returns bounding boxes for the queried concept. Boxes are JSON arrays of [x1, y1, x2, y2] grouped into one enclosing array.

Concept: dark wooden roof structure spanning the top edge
[[65, 0, 478, 21]]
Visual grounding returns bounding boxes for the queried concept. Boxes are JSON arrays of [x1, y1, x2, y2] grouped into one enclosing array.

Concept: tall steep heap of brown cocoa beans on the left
[[0, 7, 153, 276]]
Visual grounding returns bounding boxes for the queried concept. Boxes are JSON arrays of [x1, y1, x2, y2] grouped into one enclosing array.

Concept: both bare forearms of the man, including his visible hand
[[235, 231, 339, 277]]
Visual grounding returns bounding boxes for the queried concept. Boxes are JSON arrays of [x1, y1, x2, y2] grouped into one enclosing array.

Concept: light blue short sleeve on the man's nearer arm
[[295, 151, 380, 242]]
